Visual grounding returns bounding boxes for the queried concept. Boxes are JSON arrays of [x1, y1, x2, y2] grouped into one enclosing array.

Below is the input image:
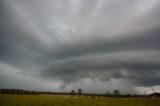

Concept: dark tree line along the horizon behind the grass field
[[0, 88, 160, 98]]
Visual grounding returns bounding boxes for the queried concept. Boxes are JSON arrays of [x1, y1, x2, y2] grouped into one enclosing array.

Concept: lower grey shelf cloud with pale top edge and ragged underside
[[42, 52, 160, 86]]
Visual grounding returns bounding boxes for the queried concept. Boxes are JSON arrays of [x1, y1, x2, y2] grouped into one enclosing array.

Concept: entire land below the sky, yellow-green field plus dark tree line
[[0, 89, 160, 106]]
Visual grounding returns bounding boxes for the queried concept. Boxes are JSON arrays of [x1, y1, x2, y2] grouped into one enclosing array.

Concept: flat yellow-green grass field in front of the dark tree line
[[0, 95, 160, 106]]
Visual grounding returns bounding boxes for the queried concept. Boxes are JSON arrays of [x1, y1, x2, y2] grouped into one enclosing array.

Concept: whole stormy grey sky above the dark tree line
[[0, 0, 160, 94]]
